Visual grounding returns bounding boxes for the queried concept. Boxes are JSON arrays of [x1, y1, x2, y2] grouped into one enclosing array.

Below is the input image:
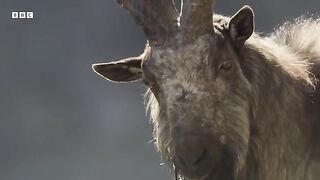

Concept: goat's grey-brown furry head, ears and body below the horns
[[93, 4, 320, 180]]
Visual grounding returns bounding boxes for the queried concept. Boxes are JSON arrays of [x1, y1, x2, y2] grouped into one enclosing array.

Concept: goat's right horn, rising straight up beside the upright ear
[[180, 0, 214, 40]]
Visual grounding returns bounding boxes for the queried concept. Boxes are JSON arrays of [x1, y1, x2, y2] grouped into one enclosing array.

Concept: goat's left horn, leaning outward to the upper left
[[117, 0, 179, 45]]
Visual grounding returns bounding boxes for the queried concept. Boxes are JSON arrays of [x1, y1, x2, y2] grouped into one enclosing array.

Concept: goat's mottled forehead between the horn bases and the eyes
[[144, 34, 231, 72]]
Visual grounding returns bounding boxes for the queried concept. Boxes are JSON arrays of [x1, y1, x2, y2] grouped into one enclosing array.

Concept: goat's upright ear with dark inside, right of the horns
[[228, 5, 254, 45]]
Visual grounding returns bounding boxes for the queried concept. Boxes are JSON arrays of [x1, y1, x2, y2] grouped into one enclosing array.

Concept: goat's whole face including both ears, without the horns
[[94, 7, 253, 179]]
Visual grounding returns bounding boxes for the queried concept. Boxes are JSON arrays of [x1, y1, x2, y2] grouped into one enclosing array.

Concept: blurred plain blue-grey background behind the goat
[[0, 0, 320, 180]]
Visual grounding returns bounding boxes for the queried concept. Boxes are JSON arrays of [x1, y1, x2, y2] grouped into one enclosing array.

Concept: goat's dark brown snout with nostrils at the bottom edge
[[173, 128, 220, 178]]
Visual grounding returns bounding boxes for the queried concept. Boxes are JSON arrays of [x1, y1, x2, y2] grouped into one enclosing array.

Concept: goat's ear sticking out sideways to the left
[[92, 57, 142, 82]]
